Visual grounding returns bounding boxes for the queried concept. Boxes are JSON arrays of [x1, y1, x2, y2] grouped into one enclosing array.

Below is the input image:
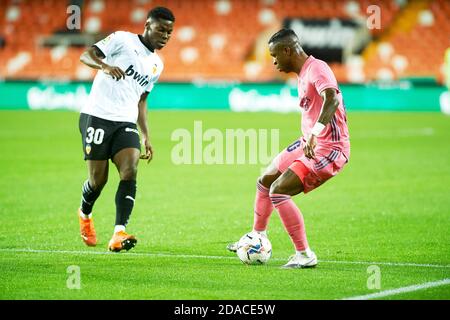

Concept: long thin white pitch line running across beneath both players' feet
[[0, 248, 450, 268]]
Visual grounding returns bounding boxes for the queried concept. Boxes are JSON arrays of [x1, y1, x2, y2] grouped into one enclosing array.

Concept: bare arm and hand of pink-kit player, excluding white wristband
[[303, 88, 339, 159]]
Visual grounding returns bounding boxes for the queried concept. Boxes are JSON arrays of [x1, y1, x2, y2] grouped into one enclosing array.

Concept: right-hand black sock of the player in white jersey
[[116, 180, 136, 226]]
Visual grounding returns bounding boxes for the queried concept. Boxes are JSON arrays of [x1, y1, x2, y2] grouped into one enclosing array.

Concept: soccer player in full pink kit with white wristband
[[227, 29, 350, 268]]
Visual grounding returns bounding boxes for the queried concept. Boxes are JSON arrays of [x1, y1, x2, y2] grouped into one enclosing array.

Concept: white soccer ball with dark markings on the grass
[[236, 232, 272, 264]]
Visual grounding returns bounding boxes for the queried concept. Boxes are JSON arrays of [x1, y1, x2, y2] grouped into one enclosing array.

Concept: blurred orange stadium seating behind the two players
[[0, 0, 450, 82]]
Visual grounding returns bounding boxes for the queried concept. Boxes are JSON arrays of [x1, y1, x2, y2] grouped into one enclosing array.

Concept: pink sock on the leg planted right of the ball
[[270, 194, 309, 251]]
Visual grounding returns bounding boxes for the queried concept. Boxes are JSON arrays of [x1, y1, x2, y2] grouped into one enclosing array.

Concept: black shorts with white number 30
[[79, 113, 141, 160]]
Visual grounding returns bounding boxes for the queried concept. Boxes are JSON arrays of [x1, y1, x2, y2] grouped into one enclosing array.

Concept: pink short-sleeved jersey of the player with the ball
[[298, 56, 350, 159]]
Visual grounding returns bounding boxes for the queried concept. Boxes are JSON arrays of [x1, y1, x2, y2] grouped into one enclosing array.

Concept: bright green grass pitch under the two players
[[0, 111, 450, 300]]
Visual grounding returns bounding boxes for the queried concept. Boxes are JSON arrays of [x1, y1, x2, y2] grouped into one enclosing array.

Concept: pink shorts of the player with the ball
[[273, 139, 350, 193]]
